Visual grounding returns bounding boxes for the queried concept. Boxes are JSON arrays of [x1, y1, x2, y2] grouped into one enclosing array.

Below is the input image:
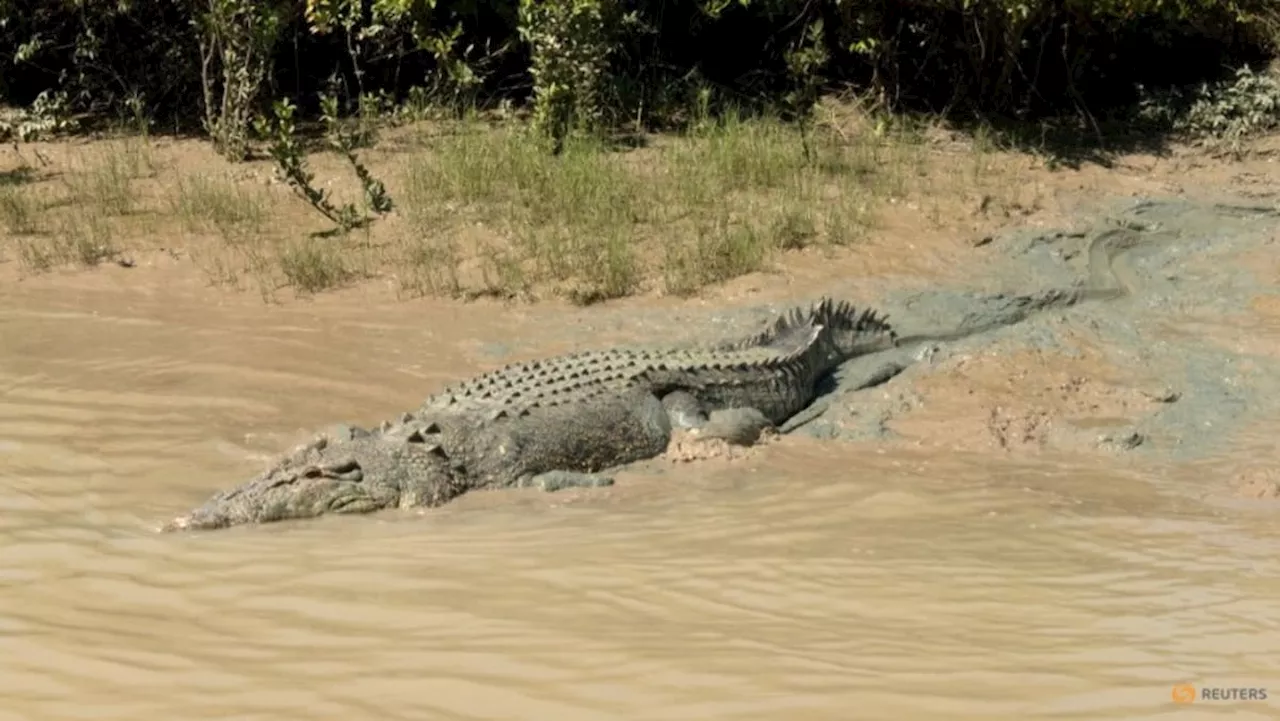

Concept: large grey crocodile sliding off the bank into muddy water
[[163, 297, 897, 530]]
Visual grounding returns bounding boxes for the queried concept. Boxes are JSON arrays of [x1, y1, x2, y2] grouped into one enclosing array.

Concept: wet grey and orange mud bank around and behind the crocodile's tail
[[529, 197, 1280, 461]]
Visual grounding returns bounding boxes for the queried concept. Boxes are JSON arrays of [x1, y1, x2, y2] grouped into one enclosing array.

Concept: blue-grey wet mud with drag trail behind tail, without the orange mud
[[797, 198, 1280, 460]]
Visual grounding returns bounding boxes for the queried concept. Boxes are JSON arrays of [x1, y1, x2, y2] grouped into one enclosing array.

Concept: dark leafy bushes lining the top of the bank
[[0, 0, 1280, 145]]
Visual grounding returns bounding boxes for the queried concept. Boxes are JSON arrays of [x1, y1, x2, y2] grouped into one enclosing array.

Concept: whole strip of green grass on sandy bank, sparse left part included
[[0, 102, 962, 304]]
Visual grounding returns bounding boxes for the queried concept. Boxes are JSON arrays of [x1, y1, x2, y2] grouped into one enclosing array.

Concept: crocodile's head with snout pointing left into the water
[[160, 425, 460, 531]]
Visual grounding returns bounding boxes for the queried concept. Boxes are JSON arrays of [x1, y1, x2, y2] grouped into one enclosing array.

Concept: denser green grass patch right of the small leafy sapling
[[392, 108, 911, 302]]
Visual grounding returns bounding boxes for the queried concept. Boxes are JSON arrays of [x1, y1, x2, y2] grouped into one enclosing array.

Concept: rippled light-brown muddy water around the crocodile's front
[[0, 277, 1280, 721]]
